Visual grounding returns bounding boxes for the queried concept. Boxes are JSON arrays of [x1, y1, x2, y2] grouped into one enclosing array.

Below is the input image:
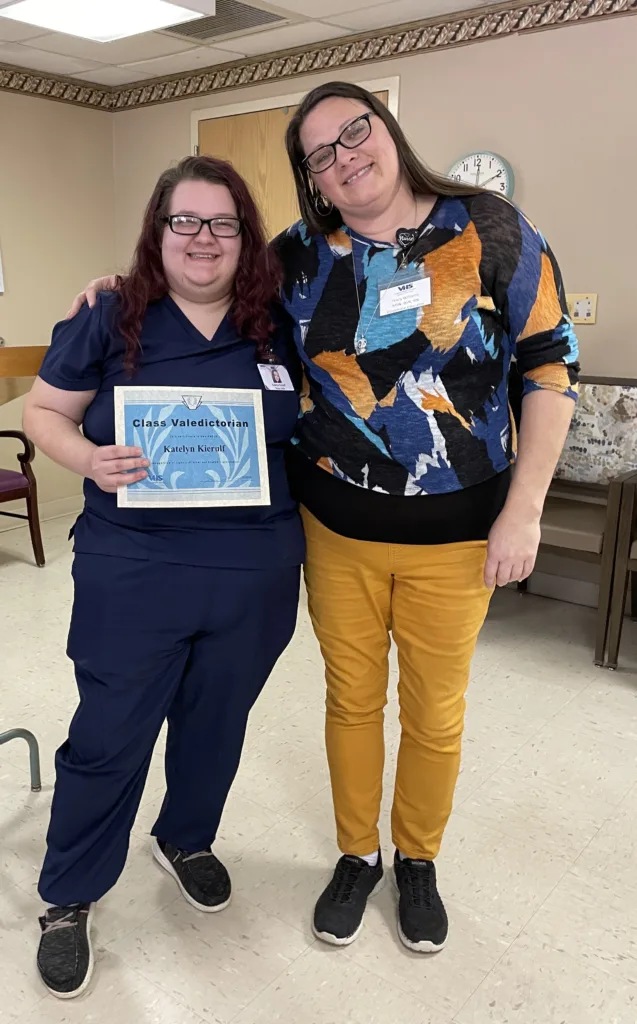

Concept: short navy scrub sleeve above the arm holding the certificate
[[39, 295, 109, 391]]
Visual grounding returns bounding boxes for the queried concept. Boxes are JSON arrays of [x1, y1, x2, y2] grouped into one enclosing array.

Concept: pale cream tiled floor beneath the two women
[[0, 520, 637, 1024]]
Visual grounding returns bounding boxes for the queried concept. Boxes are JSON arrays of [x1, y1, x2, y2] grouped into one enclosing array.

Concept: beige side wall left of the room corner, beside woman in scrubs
[[0, 92, 115, 512]]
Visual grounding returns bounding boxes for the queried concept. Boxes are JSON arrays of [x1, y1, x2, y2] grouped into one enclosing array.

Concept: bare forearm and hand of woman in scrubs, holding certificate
[[23, 377, 148, 493]]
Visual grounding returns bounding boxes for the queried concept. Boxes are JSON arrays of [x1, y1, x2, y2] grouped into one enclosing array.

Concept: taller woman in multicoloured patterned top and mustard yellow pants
[[68, 83, 578, 952]]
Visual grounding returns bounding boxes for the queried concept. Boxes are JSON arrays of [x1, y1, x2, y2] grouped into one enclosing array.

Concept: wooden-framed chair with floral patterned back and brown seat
[[518, 377, 637, 666]]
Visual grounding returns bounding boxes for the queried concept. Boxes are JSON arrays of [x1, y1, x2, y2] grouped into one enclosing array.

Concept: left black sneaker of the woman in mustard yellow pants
[[312, 850, 383, 946]]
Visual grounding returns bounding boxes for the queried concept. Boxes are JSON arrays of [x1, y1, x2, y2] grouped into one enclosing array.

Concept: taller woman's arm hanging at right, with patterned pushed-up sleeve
[[478, 197, 580, 588]]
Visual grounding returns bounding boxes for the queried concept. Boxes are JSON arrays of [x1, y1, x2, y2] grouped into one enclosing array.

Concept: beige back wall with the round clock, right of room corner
[[114, 17, 637, 376]]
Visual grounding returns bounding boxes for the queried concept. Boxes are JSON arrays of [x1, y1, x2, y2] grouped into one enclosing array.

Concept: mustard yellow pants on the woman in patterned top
[[303, 510, 491, 860]]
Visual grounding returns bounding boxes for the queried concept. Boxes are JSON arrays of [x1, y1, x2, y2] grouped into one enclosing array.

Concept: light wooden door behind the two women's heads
[[199, 92, 388, 238]]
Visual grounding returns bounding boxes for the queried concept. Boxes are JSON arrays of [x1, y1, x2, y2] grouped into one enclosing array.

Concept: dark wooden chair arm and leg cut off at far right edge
[[606, 473, 637, 670]]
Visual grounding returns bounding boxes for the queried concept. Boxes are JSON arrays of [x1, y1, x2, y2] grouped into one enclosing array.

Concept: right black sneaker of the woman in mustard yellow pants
[[393, 850, 449, 953]]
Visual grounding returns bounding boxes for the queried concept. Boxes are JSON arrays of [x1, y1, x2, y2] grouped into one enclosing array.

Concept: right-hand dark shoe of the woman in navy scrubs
[[153, 839, 231, 913]]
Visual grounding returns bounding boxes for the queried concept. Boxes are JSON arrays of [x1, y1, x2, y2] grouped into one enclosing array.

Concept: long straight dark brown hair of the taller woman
[[286, 82, 481, 234]]
